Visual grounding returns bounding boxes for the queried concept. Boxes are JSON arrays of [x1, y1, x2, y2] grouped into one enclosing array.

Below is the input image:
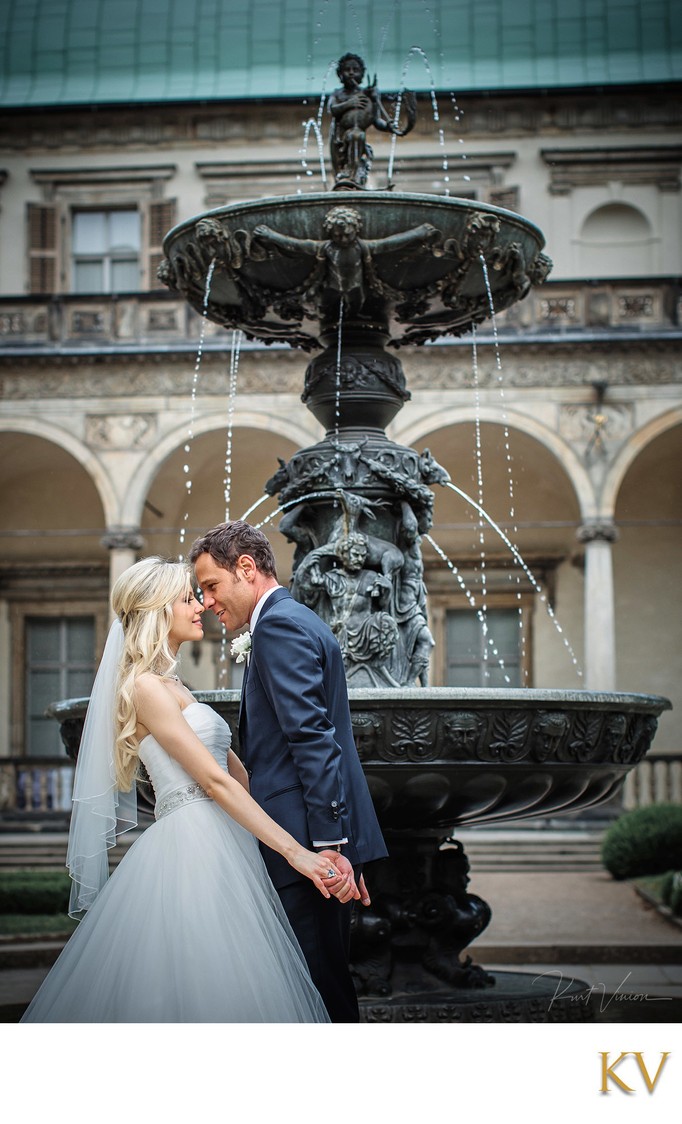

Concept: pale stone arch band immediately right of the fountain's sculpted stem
[[392, 406, 599, 522]]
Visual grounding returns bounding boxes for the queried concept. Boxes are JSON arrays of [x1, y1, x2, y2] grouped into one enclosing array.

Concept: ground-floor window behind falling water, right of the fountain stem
[[445, 609, 522, 687]]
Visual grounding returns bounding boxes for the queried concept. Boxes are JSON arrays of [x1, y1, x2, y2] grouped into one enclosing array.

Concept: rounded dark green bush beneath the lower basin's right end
[[601, 804, 682, 880]]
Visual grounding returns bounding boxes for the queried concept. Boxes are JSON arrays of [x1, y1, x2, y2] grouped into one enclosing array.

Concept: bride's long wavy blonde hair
[[111, 558, 192, 792]]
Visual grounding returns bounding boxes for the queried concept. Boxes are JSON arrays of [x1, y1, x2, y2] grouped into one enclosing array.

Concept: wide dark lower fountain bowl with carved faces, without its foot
[[49, 687, 671, 834]]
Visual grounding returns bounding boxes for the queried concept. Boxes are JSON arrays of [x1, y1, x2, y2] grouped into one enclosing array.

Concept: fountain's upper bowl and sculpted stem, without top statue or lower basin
[[160, 191, 551, 688]]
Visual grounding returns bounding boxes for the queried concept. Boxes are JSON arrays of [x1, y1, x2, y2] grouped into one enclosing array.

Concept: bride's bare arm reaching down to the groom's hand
[[135, 676, 334, 898]]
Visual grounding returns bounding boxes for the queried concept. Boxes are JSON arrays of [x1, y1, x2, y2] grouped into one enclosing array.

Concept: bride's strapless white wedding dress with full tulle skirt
[[21, 703, 329, 1023]]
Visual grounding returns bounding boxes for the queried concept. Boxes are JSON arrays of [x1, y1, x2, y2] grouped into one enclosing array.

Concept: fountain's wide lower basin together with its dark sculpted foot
[[49, 688, 671, 1023]]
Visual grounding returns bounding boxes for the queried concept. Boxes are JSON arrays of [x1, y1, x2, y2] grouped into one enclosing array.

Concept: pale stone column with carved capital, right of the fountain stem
[[576, 520, 618, 691]]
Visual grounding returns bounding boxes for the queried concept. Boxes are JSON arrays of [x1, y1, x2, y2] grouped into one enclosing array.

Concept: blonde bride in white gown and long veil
[[21, 558, 338, 1023]]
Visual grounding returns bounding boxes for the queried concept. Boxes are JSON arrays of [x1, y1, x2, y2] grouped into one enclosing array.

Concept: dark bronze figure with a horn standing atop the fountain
[[329, 54, 417, 191]]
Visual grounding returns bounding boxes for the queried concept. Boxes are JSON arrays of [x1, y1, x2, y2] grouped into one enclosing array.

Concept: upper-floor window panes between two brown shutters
[[72, 209, 140, 293]]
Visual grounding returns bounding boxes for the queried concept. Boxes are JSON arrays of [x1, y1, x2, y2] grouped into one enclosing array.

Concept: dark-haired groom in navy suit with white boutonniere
[[190, 519, 387, 1023]]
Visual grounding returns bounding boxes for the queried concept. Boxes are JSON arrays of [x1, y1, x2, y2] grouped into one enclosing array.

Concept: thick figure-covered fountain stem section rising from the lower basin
[[271, 430, 447, 687]]
